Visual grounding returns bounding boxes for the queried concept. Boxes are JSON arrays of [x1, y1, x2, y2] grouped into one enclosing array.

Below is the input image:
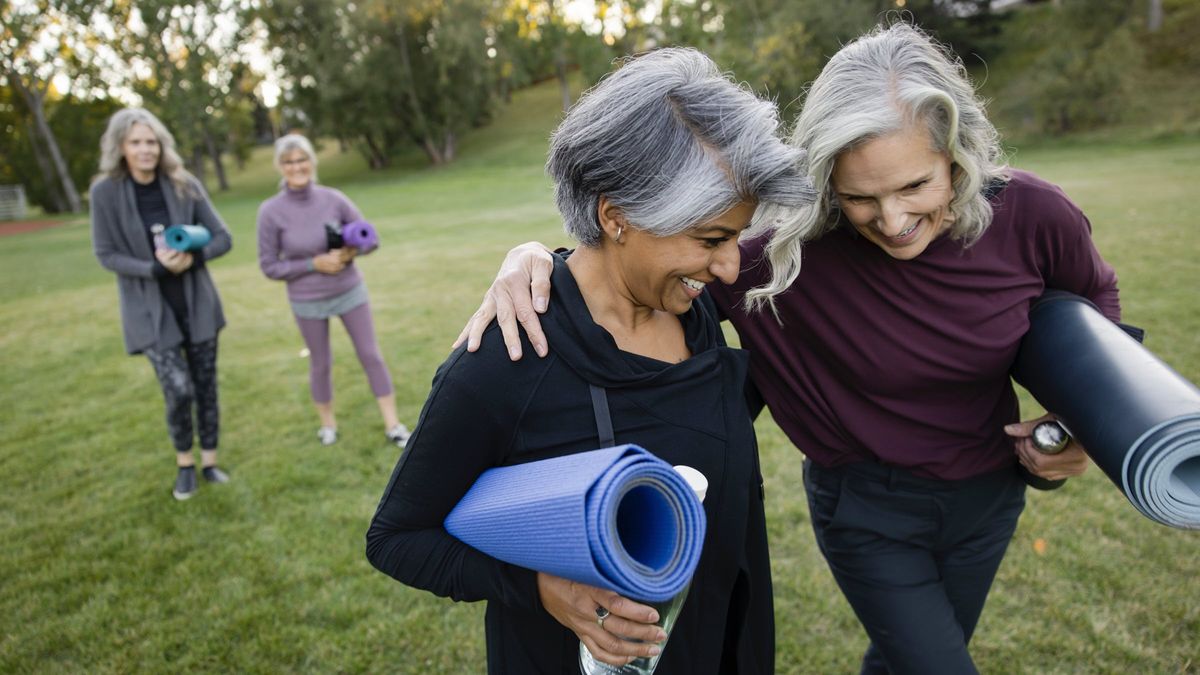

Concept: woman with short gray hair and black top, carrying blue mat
[[367, 49, 811, 675]]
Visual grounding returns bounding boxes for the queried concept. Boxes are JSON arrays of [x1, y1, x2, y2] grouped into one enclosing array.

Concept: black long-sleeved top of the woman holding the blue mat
[[367, 257, 774, 675]]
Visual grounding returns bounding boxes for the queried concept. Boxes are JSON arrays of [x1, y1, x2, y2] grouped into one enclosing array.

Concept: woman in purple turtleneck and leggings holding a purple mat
[[258, 133, 408, 448]]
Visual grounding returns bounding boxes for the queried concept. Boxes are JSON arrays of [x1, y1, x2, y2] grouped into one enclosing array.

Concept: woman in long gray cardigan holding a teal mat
[[91, 108, 232, 500]]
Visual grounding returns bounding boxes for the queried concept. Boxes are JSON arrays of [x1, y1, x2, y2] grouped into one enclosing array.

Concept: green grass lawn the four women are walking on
[[0, 79, 1200, 674]]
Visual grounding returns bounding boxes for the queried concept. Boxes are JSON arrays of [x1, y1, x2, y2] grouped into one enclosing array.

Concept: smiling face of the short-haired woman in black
[[620, 202, 757, 315]]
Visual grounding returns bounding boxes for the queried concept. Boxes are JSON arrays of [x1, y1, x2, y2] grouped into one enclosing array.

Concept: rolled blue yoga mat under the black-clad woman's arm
[[445, 444, 706, 602]]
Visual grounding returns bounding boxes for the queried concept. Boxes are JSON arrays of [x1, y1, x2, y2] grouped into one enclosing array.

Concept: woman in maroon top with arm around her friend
[[460, 24, 1120, 674]]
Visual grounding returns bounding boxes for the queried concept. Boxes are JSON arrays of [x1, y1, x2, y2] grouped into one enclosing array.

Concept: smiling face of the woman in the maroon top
[[832, 127, 954, 261]]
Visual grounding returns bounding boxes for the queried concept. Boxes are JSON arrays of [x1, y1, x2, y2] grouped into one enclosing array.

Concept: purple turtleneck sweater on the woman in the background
[[258, 183, 362, 301]]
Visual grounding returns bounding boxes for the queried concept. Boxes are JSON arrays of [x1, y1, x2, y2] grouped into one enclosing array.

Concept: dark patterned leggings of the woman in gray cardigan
[[143, 338, 221, 453]]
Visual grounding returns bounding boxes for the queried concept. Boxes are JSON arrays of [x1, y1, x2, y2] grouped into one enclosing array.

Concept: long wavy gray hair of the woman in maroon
[[746, 23, 1008, 309]]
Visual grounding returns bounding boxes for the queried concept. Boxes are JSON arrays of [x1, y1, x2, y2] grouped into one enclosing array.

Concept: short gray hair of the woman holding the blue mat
[[546, 48, 815, 246]]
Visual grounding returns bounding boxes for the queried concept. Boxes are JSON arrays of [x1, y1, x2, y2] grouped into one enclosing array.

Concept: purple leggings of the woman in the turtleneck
[[293, 297, 392, 404]]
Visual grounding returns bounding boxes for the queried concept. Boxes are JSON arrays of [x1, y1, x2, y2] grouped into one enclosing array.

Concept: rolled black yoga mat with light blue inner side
[[1013, 291, 1200, 530]]
